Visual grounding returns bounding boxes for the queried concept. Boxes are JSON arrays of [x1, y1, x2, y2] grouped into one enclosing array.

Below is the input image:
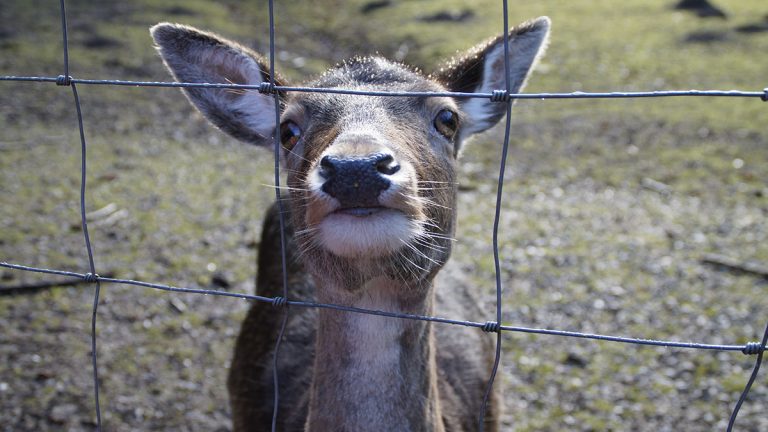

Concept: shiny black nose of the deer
[[320, 153, 400, 208]]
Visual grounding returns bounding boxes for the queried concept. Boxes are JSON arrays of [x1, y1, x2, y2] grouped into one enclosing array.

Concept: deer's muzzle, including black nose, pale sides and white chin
[[305, 153, 424, 259]]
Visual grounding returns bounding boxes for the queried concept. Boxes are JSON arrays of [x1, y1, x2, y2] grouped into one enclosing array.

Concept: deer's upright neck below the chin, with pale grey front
[[307, 277, 444, 431]]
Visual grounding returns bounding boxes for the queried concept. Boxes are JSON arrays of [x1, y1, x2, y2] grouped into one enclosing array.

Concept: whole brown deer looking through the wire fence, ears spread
[[151, 17, 550, 432]]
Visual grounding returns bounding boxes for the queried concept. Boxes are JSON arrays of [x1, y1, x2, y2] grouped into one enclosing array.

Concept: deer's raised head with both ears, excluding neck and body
[[152, 17, 549, 291]]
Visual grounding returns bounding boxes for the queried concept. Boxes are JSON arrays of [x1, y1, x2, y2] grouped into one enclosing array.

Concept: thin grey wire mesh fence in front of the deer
[[0, 0, 768, 431]]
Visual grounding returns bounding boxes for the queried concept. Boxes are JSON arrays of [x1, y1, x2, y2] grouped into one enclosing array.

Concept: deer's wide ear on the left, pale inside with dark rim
[[150, 23, 280, 145]]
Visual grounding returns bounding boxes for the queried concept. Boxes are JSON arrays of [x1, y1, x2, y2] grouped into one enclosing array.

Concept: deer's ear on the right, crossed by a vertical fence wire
[[432, 17, 550, 139]]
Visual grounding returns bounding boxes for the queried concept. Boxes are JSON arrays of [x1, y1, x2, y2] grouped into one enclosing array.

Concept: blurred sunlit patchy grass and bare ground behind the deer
[[0, 0, 768, 431]]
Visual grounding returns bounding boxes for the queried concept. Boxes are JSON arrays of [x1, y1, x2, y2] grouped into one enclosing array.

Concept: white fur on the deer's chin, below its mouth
[[319, 209, 421, 258]]
